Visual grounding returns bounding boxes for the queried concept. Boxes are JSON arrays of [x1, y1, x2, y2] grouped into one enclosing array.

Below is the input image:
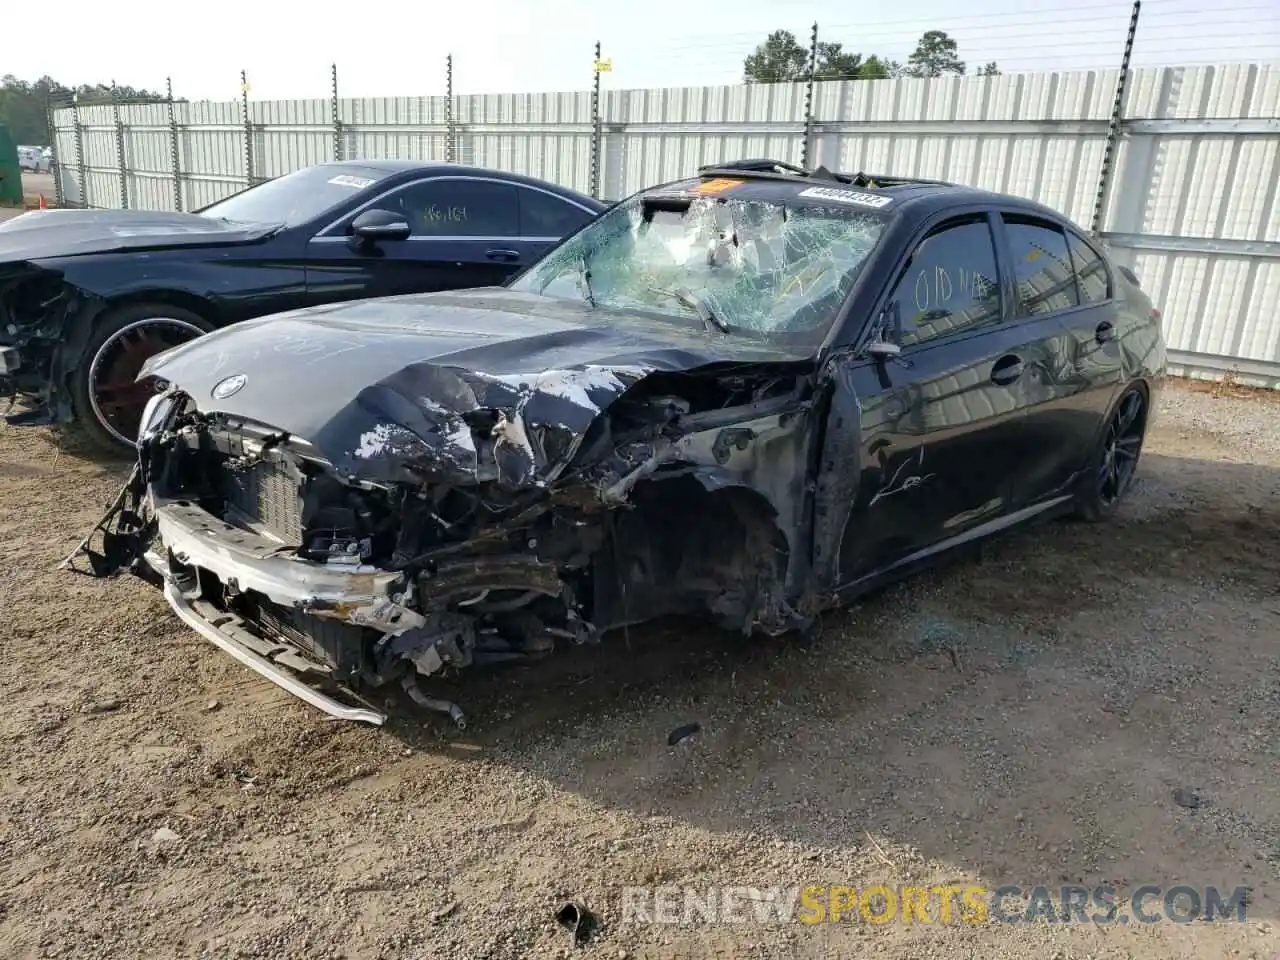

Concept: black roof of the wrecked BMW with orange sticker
[[643, 159, 1071, 229]]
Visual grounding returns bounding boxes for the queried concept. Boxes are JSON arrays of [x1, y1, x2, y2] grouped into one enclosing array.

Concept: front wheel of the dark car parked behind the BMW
[[70, 303, 214, 456]]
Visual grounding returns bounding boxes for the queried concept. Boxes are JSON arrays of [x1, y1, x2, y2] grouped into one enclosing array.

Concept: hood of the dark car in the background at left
[[0, 210, 279, 264]]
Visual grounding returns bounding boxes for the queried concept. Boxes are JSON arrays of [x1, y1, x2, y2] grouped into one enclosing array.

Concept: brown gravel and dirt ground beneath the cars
[[0, 384, 1280, 960]]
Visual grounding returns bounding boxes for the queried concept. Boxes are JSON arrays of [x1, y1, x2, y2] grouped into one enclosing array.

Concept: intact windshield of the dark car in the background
[[197, 166, 387, 227]]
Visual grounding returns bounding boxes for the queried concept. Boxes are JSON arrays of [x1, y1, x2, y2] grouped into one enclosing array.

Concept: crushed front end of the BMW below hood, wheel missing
[[82, 371, 809, 726]]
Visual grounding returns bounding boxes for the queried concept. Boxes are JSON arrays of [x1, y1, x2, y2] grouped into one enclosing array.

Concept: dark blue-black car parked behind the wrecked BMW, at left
[[0, 160, 605, 453]]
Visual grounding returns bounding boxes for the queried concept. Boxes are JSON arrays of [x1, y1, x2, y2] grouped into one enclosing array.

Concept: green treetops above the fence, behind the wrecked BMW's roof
[[742, 29, 1000, 83]]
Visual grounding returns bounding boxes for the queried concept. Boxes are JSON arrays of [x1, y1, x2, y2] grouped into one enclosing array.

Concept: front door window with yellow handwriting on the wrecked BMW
[[890, 218, 1001, 347]]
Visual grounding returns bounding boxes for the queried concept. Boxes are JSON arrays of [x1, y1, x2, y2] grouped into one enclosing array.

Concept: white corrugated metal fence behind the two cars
[[45, 64, 1280, 385]]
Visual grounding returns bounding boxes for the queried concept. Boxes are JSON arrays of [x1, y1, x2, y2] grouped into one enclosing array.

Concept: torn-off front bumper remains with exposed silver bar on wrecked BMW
[[73, 455, 565, 730]]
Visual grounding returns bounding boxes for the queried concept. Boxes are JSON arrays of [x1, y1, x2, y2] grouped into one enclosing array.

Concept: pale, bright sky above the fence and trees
[[12, 0, 1280, 100]]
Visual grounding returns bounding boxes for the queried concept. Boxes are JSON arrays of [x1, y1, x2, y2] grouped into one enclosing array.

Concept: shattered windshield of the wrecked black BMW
[[512, 196, 886, 339]]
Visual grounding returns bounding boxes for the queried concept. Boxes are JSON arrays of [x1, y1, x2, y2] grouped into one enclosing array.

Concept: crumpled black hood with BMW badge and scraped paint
[[140, 288, 806, 485]]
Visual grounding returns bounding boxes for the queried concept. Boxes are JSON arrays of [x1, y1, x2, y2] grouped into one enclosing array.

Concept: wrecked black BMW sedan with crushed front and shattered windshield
[[74, 163, 1165, 723]]
